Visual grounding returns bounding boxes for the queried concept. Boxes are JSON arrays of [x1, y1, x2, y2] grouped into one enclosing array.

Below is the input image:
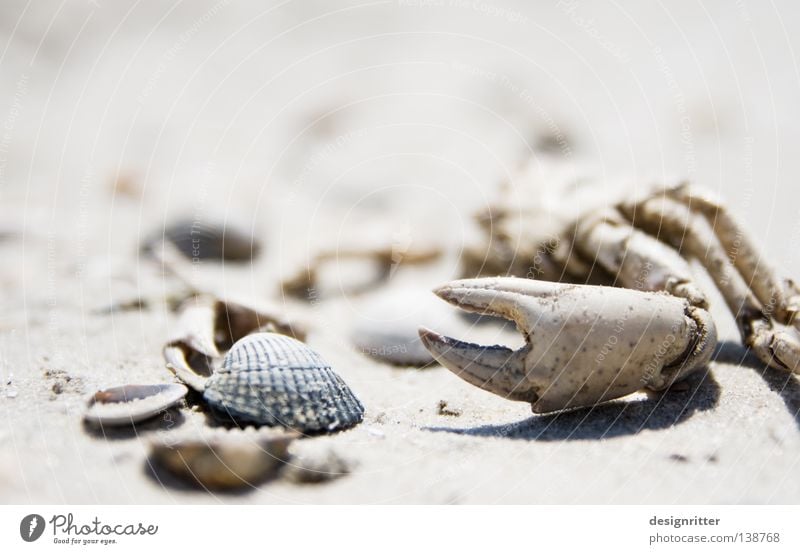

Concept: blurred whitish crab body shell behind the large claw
[[461, 155, 677, 285]]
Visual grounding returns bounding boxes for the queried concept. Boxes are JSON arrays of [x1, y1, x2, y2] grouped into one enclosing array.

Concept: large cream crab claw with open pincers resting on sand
[[419, 277, 717, 413]]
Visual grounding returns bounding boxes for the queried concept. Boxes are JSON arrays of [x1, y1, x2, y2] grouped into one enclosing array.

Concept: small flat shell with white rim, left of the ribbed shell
[[83, 383, 188, 425]]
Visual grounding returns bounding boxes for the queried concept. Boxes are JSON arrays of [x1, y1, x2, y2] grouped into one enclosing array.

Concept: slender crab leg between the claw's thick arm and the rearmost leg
[[622, 197, 800, 372]]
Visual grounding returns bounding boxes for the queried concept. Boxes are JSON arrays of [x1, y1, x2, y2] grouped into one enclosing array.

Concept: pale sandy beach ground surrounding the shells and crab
[[0, 0, 800, 503]]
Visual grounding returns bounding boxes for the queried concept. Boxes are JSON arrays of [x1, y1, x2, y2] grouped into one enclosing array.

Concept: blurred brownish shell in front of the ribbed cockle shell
[[150, 426, 297, 490]]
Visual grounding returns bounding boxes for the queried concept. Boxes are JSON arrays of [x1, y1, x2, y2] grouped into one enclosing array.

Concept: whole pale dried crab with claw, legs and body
[[420, 160, 800, 412]]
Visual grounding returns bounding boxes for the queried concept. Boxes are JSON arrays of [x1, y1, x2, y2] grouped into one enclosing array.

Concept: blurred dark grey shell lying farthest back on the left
[[142, 219, 261, 262]]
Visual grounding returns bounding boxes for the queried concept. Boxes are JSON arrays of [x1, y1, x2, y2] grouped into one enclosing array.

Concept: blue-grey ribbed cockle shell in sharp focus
[[203, 333, 364, 433]]
